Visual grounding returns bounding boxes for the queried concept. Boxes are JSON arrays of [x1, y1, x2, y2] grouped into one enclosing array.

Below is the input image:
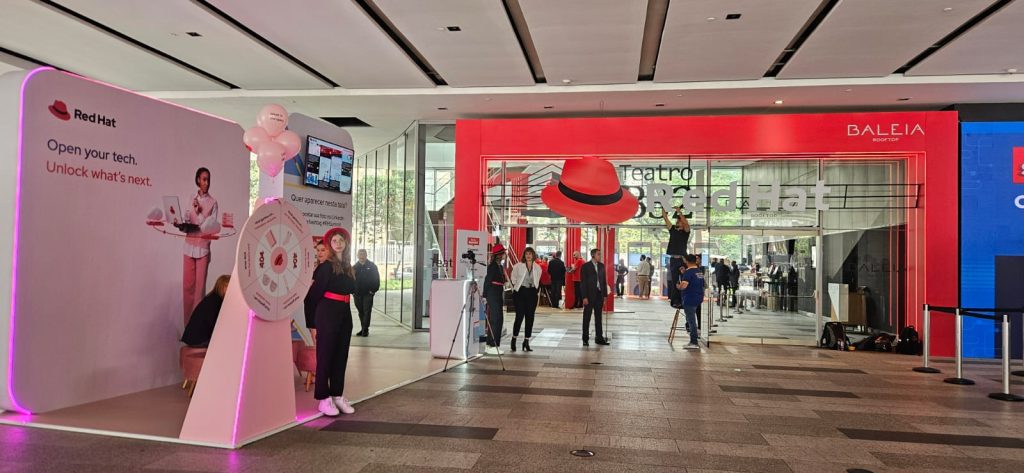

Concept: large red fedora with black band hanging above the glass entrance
[[541, 157, 638, 224]]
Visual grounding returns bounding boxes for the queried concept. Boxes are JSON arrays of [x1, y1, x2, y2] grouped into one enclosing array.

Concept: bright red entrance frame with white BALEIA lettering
[[455, 112, 958, 355]]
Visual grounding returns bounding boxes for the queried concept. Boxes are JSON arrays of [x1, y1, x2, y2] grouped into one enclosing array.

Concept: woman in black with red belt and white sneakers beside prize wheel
[[305, 228, 355, 416]]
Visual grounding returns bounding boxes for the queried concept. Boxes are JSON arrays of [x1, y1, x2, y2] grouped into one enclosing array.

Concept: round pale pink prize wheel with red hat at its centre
[[238, 200, 316, 320]]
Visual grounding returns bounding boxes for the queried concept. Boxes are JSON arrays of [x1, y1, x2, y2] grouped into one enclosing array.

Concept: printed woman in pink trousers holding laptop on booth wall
[[179, 168, 220, 326]]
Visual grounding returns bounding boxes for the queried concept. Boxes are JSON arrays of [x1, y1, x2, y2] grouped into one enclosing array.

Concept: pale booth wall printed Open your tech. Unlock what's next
[[0, 69, 249, 412]]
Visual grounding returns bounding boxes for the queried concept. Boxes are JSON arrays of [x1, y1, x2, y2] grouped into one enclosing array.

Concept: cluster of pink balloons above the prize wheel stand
[[242, 103, 302, 177]]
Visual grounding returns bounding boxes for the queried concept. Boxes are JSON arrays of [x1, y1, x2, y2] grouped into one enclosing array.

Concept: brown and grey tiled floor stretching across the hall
[[0, 301, 1024, 473]]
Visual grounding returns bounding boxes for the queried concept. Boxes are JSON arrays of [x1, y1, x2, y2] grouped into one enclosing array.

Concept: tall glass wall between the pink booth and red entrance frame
[[352, 123, 455, 330]]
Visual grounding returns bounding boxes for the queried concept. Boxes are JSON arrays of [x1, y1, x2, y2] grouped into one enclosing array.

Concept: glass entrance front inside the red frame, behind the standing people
[[482, 156, 921, 346]]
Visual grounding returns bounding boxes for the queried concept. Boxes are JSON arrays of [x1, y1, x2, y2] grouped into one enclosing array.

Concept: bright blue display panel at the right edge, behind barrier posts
[[959, 122, 1024, 357]]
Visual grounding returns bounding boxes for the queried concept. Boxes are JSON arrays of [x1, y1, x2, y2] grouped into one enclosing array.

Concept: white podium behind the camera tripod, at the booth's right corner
[[430, 280, 483, 359]]
